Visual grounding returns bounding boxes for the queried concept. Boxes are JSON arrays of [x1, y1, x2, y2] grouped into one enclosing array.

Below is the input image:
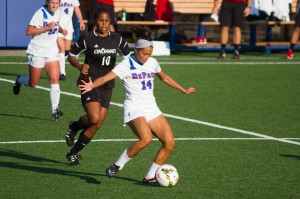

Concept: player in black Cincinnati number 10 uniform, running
[[66, 8, 130, 165]]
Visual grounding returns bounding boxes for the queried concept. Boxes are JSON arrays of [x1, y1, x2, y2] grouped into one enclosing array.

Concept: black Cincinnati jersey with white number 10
[[71, 31, 130, 88]]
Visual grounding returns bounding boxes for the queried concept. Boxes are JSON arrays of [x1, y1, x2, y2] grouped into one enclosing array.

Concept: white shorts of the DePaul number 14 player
[[124, 107, 162, 124]]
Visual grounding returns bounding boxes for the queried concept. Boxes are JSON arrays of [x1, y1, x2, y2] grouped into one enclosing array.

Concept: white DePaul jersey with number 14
[[112, 55, 161, 110]]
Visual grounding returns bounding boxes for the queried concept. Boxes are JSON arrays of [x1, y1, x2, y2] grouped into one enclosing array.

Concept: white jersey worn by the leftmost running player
[[26, 6, 60, 57]]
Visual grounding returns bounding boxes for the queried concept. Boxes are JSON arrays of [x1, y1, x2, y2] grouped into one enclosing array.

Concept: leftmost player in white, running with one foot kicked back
[[13, 0, 67, 120]]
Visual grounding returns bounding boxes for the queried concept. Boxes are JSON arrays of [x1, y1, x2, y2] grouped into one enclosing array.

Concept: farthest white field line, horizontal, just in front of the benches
[[0, 60, 300, 65]]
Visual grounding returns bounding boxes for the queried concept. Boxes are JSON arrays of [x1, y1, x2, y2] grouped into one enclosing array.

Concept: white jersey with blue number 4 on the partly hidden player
[[59, 0, 80, 33]]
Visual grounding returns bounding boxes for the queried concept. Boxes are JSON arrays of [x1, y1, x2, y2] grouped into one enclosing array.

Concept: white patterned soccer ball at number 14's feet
[[155, 164, 179, 187]]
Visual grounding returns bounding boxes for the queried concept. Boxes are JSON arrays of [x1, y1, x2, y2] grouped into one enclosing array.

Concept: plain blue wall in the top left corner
[[0, 0, 40, 48]]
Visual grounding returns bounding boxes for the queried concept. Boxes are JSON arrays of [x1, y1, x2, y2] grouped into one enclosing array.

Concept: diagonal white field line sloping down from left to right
[[0, 78, 300, 146]]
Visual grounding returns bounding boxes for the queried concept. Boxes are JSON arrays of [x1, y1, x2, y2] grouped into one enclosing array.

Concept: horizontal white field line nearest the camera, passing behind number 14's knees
[[0, 138, 300, 144]]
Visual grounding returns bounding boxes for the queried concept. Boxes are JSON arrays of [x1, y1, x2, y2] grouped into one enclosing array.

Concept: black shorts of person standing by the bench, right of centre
[[220, 1, 246, 28]]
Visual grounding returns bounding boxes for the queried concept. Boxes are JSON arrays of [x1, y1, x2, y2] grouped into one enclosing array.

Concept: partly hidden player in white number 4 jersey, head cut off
[[57, 0, 85, 80]]
